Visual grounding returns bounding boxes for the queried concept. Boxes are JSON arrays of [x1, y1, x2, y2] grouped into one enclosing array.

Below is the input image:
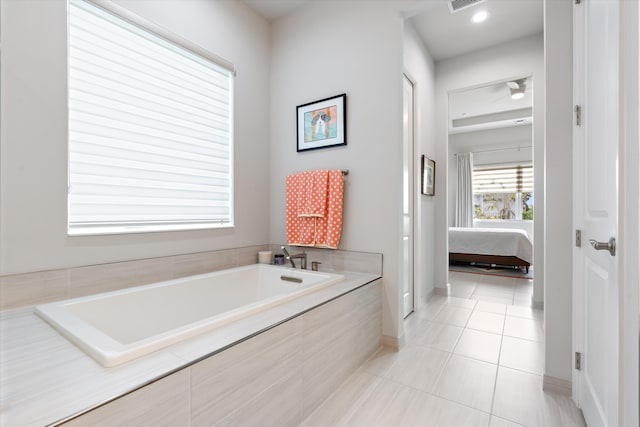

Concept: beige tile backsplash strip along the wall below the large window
[[0, 245, 268, 311]]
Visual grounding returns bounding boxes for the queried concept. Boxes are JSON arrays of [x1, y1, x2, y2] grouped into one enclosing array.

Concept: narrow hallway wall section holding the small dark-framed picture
[[403, 21, 444, 304]]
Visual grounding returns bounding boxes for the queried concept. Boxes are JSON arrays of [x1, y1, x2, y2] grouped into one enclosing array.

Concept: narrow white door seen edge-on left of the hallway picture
[[402, 76, 414, 317]]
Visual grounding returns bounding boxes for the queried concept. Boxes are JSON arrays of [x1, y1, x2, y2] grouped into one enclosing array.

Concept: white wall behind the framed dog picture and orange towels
[[269, 1, 403, 337]]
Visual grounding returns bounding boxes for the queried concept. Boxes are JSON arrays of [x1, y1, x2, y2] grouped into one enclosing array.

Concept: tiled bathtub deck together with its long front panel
[[0, 272, 382, 427]]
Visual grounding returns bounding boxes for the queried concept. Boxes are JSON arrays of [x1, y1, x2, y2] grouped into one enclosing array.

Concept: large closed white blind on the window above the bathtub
[[68, 0, 233, 235]]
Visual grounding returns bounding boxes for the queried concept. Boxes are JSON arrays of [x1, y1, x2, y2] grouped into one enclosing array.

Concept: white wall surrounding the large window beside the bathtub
[[0, 0, 270, 274]]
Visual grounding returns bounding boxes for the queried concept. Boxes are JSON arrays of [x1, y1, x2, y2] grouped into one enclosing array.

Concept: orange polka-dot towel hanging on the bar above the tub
[[285, 170, 344, 249]]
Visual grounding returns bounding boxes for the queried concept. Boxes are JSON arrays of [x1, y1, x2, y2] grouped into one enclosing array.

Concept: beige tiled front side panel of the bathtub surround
[[64, 280, 382, 427]]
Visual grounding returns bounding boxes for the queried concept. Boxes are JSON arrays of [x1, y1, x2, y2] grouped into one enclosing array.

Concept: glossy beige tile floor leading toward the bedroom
[[302, 272, 585, 427]]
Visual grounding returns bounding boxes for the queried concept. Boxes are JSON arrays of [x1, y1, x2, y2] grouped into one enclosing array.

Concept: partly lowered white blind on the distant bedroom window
[[473, 166, 533, 194]]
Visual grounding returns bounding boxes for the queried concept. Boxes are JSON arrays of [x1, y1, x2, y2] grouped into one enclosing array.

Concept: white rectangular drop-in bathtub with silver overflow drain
[[36, 264, 344, 367]]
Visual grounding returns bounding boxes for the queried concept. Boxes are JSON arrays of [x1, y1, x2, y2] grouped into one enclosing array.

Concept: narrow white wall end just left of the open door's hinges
[[536, 0, 573, 381]]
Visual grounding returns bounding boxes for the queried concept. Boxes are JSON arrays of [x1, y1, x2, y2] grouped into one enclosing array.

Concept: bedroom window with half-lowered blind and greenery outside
[[473, 165, 533, 220]]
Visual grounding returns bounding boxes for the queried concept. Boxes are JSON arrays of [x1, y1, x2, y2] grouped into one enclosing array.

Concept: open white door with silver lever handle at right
[[572, 0, 619, 427]]
